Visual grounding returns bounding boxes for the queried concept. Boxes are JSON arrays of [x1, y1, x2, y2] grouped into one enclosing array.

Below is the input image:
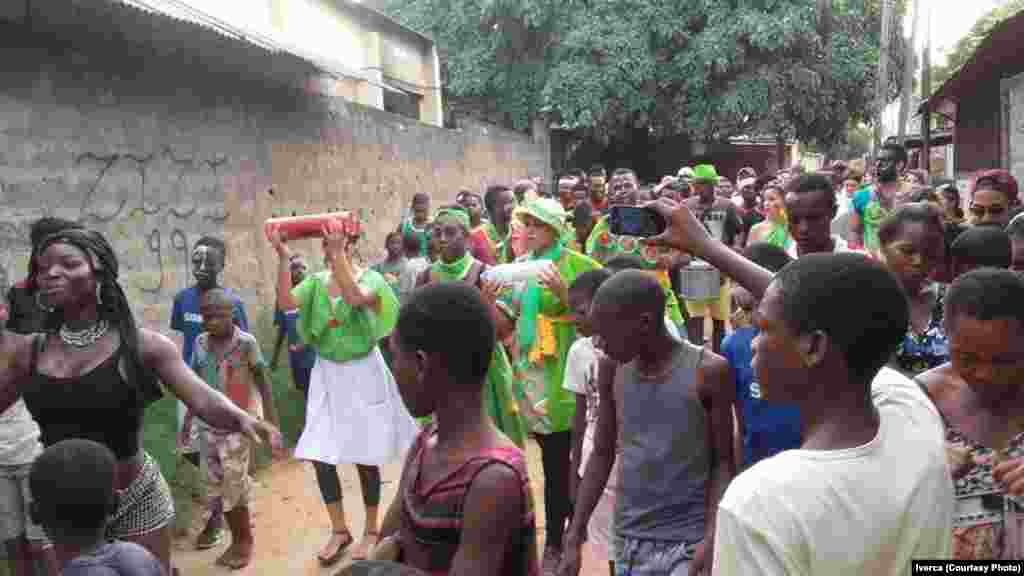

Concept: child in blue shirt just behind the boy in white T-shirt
[[722, 242, 802, 469]]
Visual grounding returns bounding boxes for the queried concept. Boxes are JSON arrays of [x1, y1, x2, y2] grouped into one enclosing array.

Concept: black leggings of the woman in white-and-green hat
[[537, 430, 572, 549]]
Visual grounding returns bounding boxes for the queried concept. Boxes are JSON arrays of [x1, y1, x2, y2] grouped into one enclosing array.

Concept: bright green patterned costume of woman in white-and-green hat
[[513, 242, 601, 434]]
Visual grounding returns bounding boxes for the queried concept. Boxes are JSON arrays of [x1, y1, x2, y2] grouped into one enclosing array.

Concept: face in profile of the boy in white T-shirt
[[752, 282, 807, 402]]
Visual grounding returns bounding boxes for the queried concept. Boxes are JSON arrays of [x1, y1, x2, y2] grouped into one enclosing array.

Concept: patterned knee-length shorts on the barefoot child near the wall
[[206, 430, 252, 512]]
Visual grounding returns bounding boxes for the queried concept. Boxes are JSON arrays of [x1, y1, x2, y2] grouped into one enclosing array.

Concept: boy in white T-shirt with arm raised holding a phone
[[653, 202, 953, 576]]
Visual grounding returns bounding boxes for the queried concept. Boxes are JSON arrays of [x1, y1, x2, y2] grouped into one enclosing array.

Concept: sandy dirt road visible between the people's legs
[[173, 443, 608, 576]]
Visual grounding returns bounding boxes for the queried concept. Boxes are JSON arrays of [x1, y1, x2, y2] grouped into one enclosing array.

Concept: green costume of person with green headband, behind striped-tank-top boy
[[421, 252, 527, 448]]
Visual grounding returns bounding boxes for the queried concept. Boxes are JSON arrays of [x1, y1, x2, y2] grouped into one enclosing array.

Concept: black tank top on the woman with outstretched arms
[[22, 336, 145, 460]]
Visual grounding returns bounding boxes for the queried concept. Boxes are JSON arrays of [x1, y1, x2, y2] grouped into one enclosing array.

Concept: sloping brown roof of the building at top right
[[922, 11, 1024, 119]]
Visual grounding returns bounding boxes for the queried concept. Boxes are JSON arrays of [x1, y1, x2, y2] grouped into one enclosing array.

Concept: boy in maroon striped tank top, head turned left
[[374, 283, 539, 576]]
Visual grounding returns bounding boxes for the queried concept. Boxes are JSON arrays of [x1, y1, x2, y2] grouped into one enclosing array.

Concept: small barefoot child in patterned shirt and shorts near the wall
[[182, 288, 278, 569]]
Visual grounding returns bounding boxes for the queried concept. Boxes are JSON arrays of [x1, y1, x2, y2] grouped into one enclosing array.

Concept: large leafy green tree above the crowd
[[385, 0, 904, 150]]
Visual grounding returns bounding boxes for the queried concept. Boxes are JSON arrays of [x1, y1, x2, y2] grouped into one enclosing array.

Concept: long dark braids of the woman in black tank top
[[32, 229, 162, 405]]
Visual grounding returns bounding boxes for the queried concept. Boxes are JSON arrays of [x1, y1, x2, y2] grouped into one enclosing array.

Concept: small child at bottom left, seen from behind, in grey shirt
[[29, 439, 166, 576]]
